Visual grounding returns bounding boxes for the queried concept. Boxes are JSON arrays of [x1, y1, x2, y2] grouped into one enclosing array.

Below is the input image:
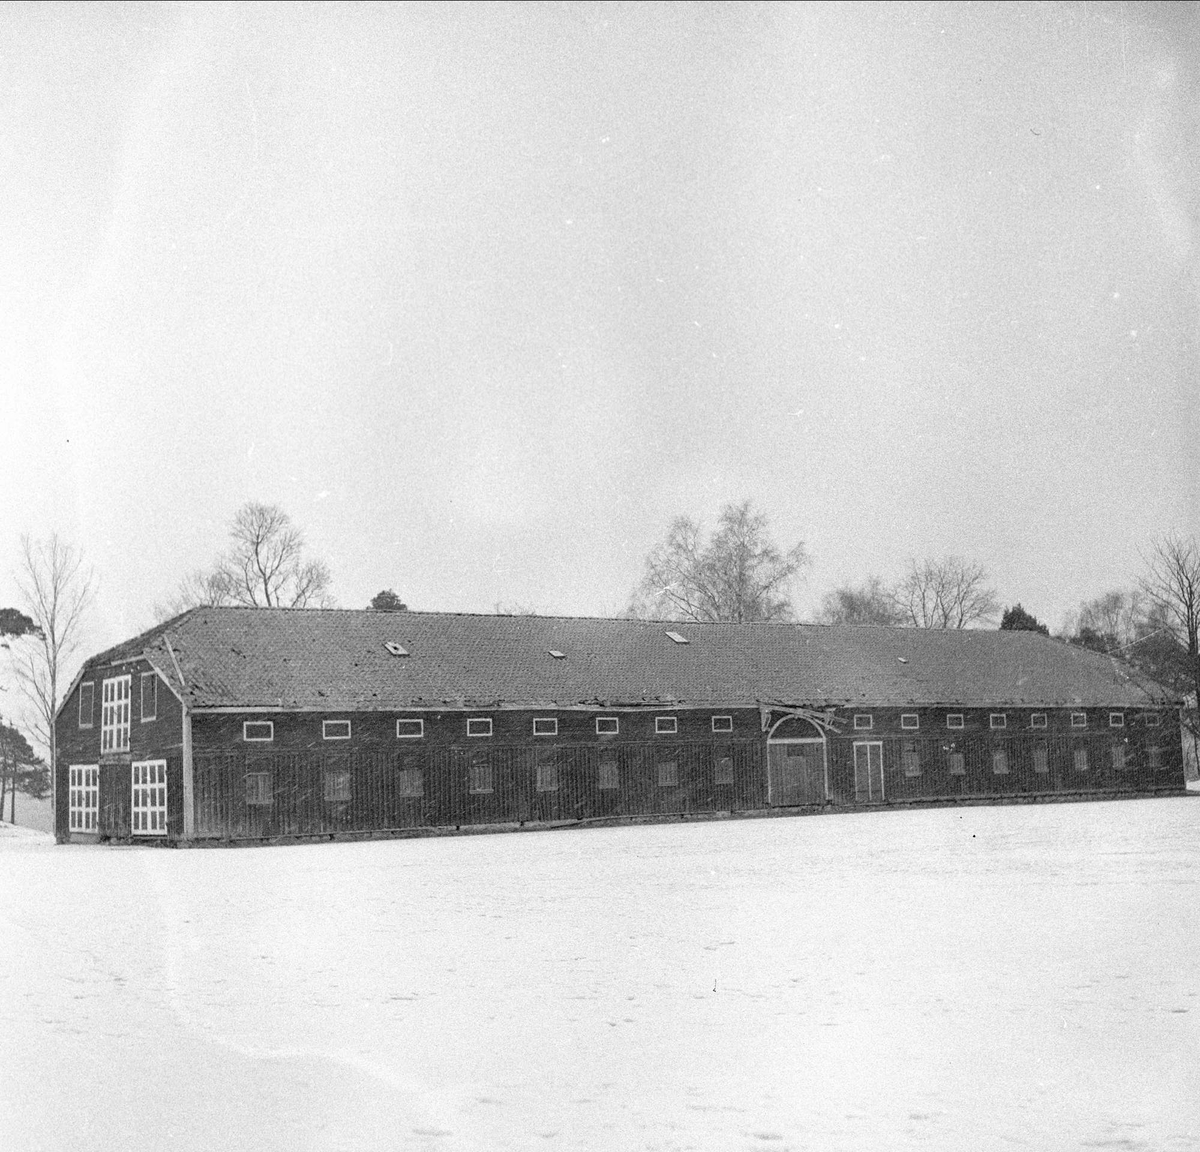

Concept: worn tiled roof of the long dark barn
[[89, 608, 1176, 712]]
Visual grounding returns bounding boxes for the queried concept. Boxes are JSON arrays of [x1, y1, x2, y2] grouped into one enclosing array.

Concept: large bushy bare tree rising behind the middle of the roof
[[629, 500, 808, 623]]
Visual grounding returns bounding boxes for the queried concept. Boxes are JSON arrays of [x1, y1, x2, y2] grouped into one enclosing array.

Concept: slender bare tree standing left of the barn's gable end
[[13, 533, 94, 779]]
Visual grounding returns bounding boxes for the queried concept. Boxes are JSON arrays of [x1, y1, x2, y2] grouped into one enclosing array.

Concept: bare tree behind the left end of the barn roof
[[157, 502, 334, 619]]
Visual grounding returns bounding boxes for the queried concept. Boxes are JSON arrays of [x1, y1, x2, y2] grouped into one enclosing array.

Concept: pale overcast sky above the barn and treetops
[[0, 2, 1200, 649]]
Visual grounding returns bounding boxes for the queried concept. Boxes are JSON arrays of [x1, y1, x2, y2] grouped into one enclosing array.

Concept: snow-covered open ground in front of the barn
[[0, 797, 1200, 1152]]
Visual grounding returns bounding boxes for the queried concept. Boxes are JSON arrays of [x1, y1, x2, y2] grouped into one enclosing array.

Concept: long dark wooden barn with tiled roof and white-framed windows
[[55, 608, 1184, 844]]
